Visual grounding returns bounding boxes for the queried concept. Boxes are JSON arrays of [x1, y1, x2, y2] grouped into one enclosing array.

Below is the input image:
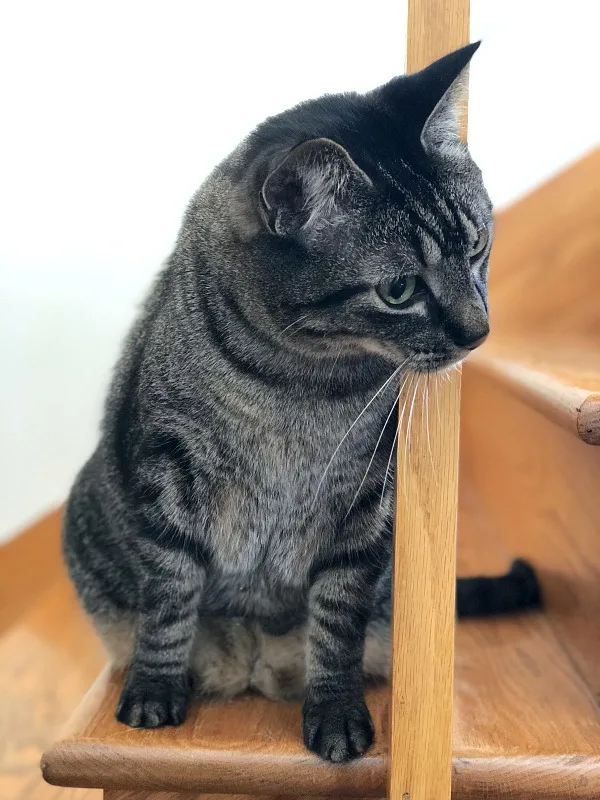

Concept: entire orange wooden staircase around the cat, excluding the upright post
[[0, 147, 600, 800]]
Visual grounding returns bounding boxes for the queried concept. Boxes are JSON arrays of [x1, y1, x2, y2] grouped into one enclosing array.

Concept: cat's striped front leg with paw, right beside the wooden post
[[303, 565, 377, 761]]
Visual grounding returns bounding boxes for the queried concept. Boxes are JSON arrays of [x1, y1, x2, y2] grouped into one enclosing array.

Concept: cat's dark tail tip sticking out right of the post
[[456, 558, 542, 617]]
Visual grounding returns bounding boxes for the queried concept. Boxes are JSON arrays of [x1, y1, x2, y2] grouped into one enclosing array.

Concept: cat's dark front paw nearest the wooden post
[[303, 697, 374, 763]]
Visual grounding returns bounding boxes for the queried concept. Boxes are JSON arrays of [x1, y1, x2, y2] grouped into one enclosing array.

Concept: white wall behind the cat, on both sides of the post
[[0, 0, 599, 537]]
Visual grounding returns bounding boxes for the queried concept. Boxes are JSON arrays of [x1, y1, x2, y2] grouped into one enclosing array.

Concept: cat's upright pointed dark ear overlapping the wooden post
[[381, 42, 481, 152]]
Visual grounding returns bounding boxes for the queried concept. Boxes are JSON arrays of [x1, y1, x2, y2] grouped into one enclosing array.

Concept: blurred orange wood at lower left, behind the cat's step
[[0, 513, 106, 800]]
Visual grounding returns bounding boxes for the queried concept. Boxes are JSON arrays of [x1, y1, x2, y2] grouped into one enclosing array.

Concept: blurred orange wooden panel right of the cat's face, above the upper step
[[490, 148, 600, 344]]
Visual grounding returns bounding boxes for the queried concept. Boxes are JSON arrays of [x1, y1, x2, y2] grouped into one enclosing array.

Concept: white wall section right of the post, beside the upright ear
[[469, 0, 600, 207]]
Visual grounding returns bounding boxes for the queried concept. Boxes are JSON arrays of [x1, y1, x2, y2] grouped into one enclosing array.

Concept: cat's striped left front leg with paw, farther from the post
[[117, 545, 204, 728]]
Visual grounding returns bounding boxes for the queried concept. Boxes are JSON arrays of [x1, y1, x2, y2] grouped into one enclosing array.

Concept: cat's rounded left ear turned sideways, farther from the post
[[261, 139, 371, 236]]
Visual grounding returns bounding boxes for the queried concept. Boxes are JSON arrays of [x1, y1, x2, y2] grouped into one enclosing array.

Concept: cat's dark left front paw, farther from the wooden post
[[116, 673, 191, 728]]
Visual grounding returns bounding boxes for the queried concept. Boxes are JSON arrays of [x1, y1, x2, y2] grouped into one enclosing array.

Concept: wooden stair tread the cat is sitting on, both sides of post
[[44, 486, 600, 798]]
